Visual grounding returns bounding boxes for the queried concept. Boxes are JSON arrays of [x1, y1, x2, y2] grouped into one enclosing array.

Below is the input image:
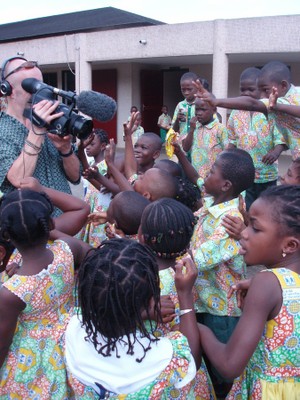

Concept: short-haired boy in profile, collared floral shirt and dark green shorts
[[190, 149, 255, 397]]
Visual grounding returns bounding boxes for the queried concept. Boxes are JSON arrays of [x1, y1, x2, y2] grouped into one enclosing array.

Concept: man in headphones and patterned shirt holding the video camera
[[0, 57, 81, 214]]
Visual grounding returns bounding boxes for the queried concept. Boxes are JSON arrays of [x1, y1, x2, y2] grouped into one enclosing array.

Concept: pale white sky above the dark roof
[[0, 0, 300, 25]]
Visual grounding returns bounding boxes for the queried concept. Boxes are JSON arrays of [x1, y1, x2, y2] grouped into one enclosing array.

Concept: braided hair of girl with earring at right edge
[[259, 185, 300, 235]]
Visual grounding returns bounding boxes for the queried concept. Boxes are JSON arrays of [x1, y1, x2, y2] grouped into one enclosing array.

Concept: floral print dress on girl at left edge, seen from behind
[[0, 240, 74, 400]]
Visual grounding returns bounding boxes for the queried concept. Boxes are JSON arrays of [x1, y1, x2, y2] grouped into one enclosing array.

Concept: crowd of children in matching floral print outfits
[[0, 57, 300, 400]]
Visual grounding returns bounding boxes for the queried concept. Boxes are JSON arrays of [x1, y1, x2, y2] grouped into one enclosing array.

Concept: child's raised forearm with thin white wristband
[[175, 256, 202, 369]]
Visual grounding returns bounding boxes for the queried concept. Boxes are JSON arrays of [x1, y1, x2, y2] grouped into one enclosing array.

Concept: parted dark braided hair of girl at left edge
[[0, 189, 53, 247]]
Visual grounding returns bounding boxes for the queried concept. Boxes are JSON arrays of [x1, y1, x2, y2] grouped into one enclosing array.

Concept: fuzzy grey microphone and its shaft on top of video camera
[[22, 78, 117, 122]]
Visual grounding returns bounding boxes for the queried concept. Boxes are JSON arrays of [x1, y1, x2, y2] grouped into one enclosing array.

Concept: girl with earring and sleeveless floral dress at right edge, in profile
[[200, 185, 300, 400]]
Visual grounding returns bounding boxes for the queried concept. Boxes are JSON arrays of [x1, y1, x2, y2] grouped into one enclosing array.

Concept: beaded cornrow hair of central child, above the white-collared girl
[[140, 198, 197, 259]]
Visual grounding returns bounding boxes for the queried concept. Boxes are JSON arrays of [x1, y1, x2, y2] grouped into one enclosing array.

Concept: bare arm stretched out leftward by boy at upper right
[[193, 80, 268, 116]]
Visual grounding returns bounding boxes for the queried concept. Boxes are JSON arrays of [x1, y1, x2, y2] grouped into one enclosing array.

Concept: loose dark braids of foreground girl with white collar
[[77, 239, 161, 362]]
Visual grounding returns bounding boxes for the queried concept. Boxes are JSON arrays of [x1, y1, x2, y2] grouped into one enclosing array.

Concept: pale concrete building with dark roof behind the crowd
[[0, 7, 300, 147]]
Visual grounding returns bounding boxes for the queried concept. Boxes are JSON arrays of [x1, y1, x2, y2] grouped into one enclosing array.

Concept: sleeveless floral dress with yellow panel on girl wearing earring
[[226, 268, 300, 400]]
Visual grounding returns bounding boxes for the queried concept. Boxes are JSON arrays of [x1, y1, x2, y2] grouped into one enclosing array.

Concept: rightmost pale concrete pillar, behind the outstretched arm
[[212, 20, 229, 124]]
